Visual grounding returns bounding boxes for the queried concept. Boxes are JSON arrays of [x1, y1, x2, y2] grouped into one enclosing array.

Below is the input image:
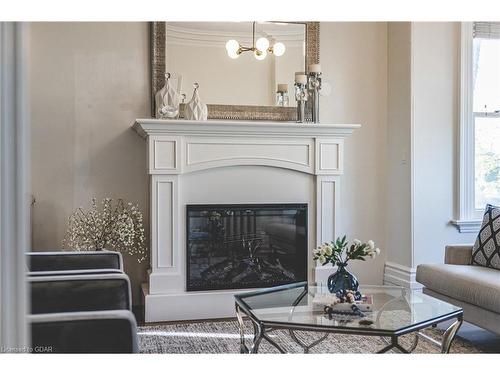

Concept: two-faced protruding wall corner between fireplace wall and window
[[387, 22, 476, 280]]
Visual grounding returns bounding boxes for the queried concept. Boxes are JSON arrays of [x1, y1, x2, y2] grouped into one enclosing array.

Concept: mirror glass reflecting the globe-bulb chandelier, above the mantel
[[166, 22, 306, 106]]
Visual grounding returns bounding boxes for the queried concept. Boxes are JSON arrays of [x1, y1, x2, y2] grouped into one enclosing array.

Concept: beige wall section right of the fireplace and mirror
[[320, 22, 387, 283]]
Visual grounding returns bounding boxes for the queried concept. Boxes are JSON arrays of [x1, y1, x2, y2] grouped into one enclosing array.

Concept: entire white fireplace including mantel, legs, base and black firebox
[[134, 119, 359, 322]]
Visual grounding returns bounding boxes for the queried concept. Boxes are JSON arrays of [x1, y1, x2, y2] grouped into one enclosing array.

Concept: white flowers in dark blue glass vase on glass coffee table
[[314, 236, 380, 294]]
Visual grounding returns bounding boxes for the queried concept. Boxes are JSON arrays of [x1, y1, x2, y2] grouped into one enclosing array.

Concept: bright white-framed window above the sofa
[[454, 22, 500, 232]]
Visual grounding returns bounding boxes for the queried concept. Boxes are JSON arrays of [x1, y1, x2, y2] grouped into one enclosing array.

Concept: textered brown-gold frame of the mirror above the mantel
[[150, 22, 319, 121]]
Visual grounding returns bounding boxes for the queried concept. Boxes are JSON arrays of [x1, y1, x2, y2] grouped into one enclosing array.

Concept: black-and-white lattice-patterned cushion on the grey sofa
[[472, 204, 500, 270]]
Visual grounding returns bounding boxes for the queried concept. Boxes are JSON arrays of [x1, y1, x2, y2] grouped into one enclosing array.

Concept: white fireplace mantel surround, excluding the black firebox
[[133, 119, 360, 322]]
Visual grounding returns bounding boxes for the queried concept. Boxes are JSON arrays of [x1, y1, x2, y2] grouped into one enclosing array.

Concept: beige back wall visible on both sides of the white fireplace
[[30, 23, 387, 303]]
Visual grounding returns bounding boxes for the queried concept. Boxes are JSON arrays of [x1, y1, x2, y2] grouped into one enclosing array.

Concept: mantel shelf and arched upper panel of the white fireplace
[[137, 119, 360, 176]]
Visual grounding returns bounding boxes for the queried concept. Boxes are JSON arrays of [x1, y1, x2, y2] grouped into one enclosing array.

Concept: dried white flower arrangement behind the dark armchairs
[[63, 198, 148, 263]]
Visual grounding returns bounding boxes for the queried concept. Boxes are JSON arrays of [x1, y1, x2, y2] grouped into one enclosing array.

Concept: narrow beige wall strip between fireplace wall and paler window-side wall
[[386, 22, 412, 267]]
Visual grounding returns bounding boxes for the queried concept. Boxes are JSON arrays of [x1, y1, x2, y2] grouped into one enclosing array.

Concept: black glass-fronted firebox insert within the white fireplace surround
[[186, 204, 307, 291]]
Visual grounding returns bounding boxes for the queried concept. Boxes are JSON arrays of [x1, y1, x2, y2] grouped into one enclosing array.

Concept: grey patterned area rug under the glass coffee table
[[138, 320, 481, 354]]
